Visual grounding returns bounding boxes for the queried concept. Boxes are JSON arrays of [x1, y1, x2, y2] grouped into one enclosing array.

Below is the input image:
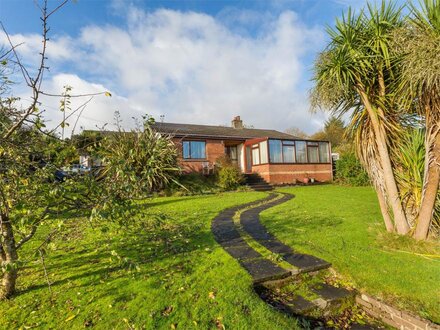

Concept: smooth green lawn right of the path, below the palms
[[261, 185, 440, 323]]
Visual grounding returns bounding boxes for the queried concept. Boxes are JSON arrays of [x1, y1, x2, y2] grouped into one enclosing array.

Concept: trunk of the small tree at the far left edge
[[0, 214, 18, 300]]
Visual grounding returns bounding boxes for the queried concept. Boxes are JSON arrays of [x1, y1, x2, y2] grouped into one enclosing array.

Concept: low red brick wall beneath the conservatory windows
[[252, 164, 332, 184]]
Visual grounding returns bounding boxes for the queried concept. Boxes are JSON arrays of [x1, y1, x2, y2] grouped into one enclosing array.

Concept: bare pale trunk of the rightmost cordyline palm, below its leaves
[[414, 129, 440, 240]]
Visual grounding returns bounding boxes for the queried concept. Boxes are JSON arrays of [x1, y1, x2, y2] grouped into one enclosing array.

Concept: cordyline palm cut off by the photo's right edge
[[396, 0, 440, 239]]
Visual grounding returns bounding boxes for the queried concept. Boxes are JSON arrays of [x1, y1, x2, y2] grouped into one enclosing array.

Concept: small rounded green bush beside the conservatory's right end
[[335, 153, 370, 186]]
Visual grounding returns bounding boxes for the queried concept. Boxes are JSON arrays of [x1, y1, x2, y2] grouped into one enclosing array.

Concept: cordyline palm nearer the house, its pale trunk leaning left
[[312, 2, 409, 234]]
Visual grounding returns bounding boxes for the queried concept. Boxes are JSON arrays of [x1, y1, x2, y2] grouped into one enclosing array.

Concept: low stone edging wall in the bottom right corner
[[356, 294, 440, 330]]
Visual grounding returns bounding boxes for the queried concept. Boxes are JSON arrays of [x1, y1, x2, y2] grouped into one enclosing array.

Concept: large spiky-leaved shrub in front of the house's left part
[[98, 113, 180, 198]]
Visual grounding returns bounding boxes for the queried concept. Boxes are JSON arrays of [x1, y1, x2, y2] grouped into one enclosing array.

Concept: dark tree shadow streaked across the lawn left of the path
[[18, 225, 216, 294]]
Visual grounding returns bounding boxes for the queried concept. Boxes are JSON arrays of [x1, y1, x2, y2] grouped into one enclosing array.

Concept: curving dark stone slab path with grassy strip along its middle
[[211, 193, 371, 329]]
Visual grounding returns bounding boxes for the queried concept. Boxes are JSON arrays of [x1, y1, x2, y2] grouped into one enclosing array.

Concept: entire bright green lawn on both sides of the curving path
[[0, 186, 440, 329]]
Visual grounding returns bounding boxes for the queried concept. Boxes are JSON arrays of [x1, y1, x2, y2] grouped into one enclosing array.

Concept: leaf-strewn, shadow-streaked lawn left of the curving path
[[0, 192, 295, 329]]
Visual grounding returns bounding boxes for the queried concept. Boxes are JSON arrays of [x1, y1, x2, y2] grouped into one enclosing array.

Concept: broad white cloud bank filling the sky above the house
[[2, 6, 323, 132]]
